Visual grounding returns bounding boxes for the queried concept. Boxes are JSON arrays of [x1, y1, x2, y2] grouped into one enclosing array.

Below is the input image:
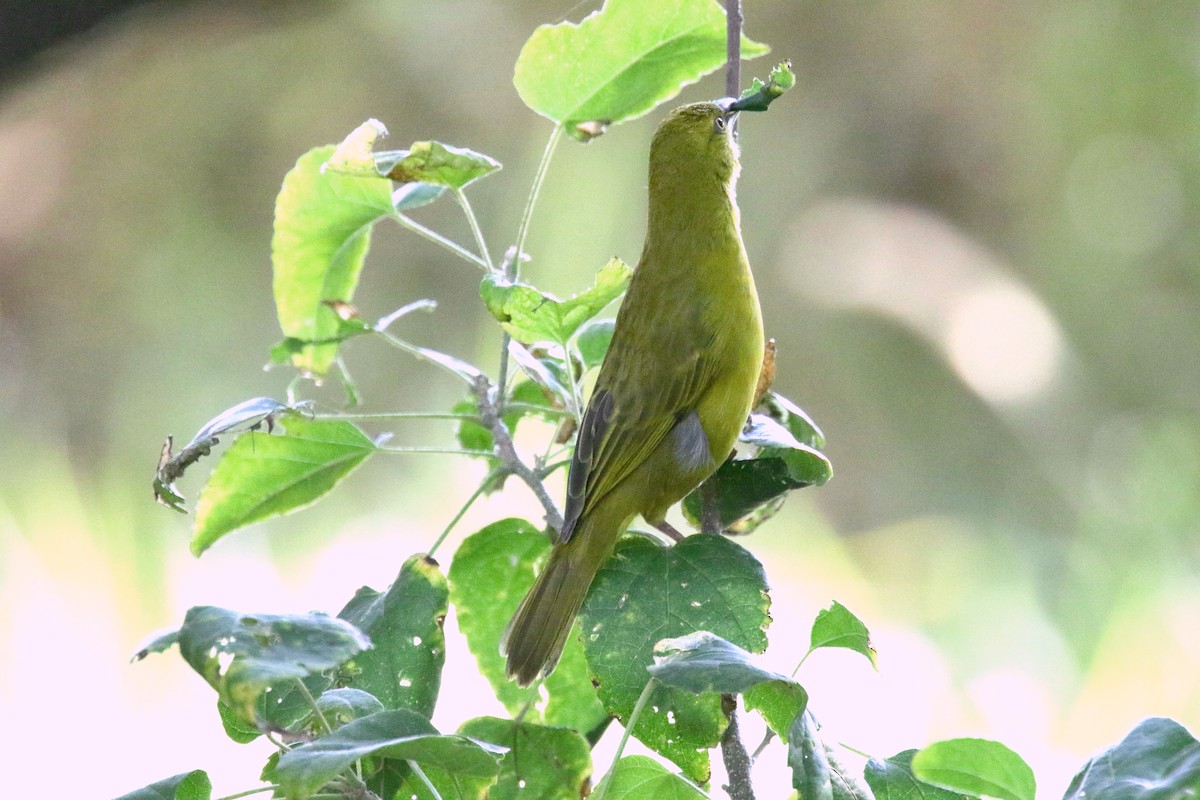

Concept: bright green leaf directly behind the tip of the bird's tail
[[450, 519, 607, 733]]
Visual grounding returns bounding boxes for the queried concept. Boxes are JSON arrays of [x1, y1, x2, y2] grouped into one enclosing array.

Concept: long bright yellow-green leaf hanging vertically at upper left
[[271, 145, 392, 377]]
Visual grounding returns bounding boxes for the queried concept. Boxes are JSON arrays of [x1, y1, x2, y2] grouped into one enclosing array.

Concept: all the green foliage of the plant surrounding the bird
[[125, 0, 1200, 800]]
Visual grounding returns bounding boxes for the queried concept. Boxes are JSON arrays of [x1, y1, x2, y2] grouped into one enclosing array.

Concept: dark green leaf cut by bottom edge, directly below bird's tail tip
[[458, 717, 592, 800]]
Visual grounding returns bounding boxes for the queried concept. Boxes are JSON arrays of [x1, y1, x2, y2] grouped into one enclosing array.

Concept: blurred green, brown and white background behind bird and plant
[[0, 0, 1200, 796]]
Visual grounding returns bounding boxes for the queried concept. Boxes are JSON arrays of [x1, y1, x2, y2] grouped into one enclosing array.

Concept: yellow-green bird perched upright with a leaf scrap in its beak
[[502, 101, 763, 686]]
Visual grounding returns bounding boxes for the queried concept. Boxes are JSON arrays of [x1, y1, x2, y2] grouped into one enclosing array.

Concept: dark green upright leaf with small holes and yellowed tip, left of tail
[[338, 554, 449, 718]]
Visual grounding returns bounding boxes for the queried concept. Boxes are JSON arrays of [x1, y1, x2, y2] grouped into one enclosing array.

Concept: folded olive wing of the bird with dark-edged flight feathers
[[559, 342, 712, 542]]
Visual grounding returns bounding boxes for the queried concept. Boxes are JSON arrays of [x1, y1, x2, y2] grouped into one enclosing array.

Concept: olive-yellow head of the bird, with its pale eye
[[650, 101, 738, 182]]
